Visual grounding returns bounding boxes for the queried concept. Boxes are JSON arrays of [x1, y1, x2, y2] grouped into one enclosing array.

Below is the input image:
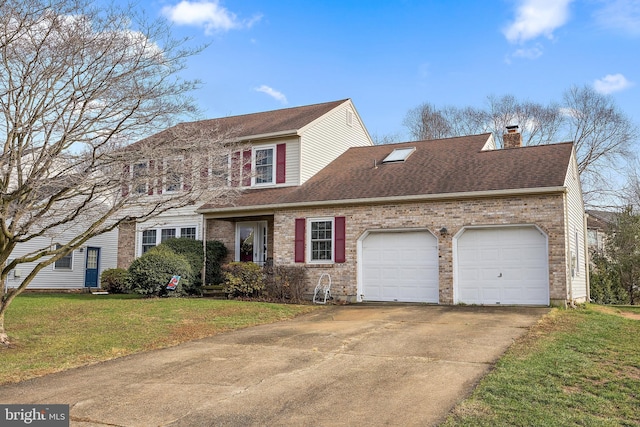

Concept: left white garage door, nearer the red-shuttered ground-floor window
[[362, 231, 439, 303]]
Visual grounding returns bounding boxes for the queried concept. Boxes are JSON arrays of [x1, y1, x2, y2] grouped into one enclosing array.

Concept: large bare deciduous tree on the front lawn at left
[[0, 0, 233, 343]]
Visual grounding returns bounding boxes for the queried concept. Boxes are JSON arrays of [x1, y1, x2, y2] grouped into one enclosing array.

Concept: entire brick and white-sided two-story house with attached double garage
[[118, 100, 589, 305]]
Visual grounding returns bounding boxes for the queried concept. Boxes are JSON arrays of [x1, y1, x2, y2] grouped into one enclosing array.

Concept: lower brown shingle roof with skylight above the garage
[[199, 134, 573, 212]]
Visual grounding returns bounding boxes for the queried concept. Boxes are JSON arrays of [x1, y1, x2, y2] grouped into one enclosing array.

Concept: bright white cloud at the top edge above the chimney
[[503, 0, 573, 43]]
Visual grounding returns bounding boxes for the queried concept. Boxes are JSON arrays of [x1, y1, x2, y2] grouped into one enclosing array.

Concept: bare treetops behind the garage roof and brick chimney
[[403, 86, 637, 204]]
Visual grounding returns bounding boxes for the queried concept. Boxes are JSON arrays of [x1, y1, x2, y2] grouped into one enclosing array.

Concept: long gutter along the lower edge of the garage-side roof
[[196, 186, 568, 214]]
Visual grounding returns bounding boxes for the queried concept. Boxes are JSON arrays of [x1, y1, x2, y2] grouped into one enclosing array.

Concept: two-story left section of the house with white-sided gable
[[118, 99, 373, 268]]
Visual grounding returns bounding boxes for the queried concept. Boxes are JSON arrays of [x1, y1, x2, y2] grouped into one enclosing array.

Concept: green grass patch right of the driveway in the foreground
[[443, 306, 640, 426]]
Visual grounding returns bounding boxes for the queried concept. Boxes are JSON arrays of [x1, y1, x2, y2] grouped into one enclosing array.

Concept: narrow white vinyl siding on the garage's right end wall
[[565, 152, 589, 302]]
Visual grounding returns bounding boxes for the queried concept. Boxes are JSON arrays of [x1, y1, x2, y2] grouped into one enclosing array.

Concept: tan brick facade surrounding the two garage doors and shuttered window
[[273, 194, 567, 304]]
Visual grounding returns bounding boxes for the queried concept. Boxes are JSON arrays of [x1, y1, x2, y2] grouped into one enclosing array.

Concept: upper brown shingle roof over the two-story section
[[130, 99, 350, 147]]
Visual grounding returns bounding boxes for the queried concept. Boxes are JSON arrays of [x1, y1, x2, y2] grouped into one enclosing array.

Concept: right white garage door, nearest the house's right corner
[[455, 227, 549, 305]]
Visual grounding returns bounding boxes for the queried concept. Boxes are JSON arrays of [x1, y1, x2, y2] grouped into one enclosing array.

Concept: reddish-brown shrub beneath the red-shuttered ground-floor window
[[265, 265, 307, 303]]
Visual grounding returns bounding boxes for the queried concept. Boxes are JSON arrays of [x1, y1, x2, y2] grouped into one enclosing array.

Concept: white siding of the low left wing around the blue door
[[7, 230, 118, 289]]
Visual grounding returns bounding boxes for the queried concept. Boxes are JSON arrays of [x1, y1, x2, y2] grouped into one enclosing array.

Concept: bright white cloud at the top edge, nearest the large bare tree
[[162, 0, 262, 34]]
